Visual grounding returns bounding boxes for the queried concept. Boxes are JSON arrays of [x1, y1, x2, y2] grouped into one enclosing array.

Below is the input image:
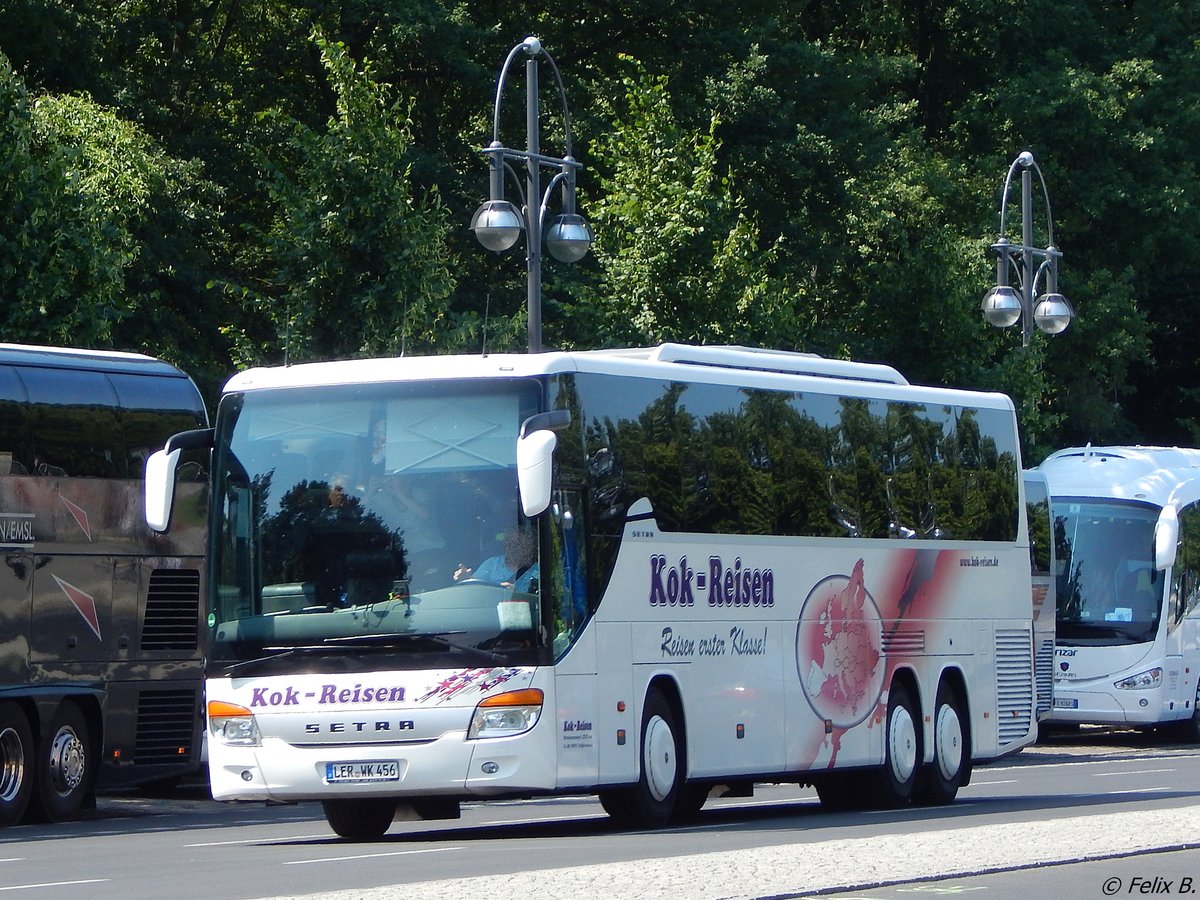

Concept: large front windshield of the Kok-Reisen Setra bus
[[209, 382, 540, 671]]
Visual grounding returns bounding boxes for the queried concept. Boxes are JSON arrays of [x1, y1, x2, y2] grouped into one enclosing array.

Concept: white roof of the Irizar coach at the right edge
[[1038, 445, 1200, 506]]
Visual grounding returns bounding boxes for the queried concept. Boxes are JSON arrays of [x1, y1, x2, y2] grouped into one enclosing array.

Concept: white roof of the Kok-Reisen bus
[[224, 343, 1012, 408]]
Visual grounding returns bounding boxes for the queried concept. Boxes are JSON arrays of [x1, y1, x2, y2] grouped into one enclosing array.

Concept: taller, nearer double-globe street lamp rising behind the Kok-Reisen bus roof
[[470, 37, 594, 353]]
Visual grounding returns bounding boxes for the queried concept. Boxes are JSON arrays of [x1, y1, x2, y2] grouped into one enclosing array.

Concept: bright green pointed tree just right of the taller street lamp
[[581, 60, 791, 343]]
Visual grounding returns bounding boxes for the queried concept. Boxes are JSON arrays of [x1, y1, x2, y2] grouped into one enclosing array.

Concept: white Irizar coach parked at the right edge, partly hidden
[[1038, 446, 1200, 740]]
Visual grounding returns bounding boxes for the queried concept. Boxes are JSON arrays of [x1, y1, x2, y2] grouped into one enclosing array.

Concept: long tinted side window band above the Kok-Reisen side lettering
[[564, 374, 1018, 541]]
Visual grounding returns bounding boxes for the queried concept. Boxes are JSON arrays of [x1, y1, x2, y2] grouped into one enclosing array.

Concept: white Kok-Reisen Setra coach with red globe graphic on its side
[[146, 344, 1037, 839]]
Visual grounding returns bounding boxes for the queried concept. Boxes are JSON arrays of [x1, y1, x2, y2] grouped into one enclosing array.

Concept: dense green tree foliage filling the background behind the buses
[[0, 0, 1200, 461]]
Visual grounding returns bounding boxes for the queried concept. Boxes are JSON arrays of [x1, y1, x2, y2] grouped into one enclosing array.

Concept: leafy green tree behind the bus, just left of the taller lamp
[[234, 34, 454, 359]]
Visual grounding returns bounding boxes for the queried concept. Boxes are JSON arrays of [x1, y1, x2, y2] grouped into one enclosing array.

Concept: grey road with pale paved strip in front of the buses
[[0, 732, 1200, 900]]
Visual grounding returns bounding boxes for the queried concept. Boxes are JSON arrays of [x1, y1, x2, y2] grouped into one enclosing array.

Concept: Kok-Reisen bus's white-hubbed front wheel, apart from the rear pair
[[600, 688, 685, 828]]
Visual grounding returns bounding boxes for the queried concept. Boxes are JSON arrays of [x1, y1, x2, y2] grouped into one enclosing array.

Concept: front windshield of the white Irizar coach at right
[[1054, 498, 1164, 644]]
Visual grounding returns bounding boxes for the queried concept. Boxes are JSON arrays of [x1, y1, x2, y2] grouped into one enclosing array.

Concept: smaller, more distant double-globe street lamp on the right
[[979, 150, 1075, 347]]
